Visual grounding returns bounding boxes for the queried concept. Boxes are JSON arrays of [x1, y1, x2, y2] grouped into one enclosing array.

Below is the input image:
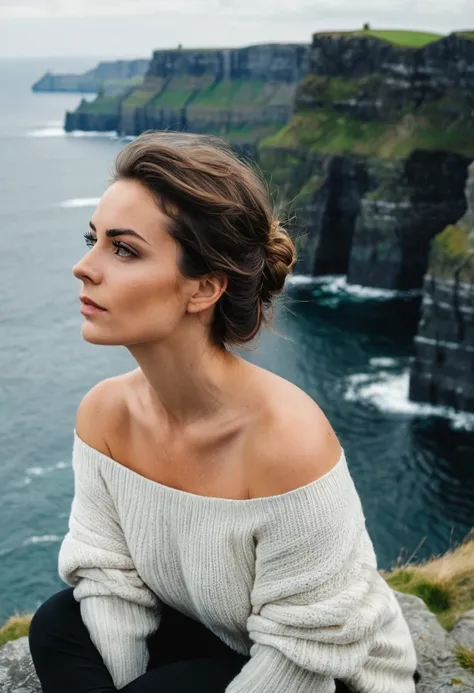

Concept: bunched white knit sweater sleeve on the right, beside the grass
[[226, 458, 417, 693]]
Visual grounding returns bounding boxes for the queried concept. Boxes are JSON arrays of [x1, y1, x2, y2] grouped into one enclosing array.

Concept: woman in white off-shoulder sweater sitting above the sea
[[30, 132, 416, 693]]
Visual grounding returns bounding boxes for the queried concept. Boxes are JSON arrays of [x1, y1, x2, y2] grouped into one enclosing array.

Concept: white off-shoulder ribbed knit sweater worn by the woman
[[59, 429, 417, 693]]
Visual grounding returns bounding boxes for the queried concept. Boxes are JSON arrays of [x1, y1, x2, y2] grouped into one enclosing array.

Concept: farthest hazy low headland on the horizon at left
[[31, 60, 150, 95]]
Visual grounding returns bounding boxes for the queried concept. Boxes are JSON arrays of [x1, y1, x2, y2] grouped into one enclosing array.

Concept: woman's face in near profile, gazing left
[[72, 180, 196, 346]]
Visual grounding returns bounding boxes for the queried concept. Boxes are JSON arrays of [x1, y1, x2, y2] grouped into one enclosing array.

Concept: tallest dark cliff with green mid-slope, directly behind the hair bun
[[258, 32, 474, 290]]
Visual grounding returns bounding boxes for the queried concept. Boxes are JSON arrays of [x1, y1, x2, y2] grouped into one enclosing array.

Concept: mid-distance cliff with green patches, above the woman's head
[[65, 44, 308, 145]]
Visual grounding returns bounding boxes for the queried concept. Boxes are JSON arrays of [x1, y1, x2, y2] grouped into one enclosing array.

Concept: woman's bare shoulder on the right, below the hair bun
[[251, 376, 342, 497]]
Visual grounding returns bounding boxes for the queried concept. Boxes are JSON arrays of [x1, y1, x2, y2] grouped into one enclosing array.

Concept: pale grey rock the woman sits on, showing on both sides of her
[[0, 592, 474, 693]]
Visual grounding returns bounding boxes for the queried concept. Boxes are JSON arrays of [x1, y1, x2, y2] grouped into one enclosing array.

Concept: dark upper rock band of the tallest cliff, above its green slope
[[296, 33, 474, 121]]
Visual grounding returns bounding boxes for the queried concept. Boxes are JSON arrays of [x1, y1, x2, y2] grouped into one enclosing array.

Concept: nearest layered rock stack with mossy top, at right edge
[[410, 164, 474, 412]]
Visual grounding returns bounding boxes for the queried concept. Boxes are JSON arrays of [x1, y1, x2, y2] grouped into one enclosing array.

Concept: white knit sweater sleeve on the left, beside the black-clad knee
[[58, 440, 161, 689]]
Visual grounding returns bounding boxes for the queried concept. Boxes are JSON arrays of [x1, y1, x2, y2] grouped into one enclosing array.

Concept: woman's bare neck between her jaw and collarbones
[[129, 332, 246, 431]]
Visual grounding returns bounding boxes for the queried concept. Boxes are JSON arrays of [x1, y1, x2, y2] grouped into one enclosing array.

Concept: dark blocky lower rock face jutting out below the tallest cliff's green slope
[[347, 150, 470, 291]]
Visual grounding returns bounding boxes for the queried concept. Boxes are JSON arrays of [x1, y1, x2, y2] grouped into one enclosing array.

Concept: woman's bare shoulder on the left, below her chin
[[76, 371, 133, 457]]
